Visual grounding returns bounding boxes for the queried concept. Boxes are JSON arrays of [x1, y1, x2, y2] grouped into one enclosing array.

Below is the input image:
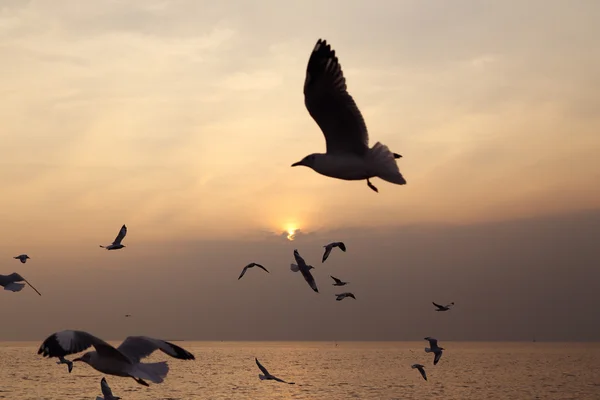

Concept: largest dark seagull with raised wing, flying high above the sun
[[292, 39, 406, 192]]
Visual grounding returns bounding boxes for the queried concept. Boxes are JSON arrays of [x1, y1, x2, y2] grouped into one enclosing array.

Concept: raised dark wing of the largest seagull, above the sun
[[304, 39, 369, 156]]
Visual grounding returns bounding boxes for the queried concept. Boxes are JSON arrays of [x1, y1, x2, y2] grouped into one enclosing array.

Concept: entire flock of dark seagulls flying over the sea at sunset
[[0, 39, 454, 400]]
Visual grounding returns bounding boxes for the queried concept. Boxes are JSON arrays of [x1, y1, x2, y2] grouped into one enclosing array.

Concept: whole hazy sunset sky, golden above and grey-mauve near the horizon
[[0, 0, 600, 340]]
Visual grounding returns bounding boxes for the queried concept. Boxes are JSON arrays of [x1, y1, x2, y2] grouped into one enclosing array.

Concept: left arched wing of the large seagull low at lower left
[[38, 330, 131, 363]]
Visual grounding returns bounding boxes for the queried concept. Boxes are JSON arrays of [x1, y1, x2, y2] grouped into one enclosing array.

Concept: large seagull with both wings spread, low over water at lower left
[[38, 330, 195, 386]]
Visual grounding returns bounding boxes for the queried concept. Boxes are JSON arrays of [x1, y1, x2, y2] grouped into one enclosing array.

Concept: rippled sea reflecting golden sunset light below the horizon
[[0, 340, 600, 400]]
